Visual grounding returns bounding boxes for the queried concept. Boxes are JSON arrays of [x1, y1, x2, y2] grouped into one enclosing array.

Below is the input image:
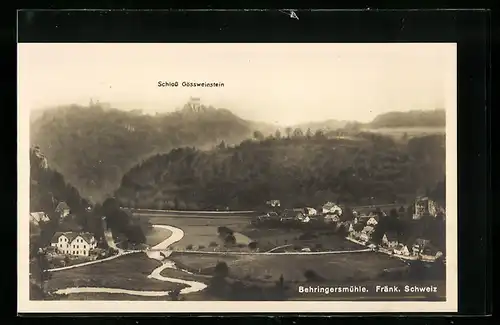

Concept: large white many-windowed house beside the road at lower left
[[50, 231, 97, 256]]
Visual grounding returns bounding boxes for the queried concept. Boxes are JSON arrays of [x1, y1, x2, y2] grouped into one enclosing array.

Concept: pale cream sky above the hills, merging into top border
[[18, 43, 456, 124]]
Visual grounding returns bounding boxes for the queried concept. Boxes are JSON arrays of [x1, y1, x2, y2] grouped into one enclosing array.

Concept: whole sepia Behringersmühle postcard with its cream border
[[18, 43, 458, 313]]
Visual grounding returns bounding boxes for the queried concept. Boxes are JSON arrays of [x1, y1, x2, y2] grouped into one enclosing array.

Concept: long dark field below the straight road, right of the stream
[[171, 252, 405, 282]]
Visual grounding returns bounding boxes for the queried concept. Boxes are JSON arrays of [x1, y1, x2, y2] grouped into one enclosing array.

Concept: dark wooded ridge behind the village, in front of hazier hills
[[115, 132, 445, 209]]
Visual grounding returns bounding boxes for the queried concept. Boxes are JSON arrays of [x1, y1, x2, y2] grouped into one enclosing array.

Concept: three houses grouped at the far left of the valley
[[30, 201, 99, 257]]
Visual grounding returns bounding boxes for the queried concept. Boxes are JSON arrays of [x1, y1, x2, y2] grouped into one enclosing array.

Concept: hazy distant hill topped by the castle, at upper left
[[30, 104, 268, 202]]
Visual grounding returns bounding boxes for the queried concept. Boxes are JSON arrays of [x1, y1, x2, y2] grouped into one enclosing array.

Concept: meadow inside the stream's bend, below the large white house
[[47, 253, 185, 292]]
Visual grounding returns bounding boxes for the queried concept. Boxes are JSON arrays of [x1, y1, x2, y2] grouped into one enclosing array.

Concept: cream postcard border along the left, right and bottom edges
[[17, 43, 458, 313]]
